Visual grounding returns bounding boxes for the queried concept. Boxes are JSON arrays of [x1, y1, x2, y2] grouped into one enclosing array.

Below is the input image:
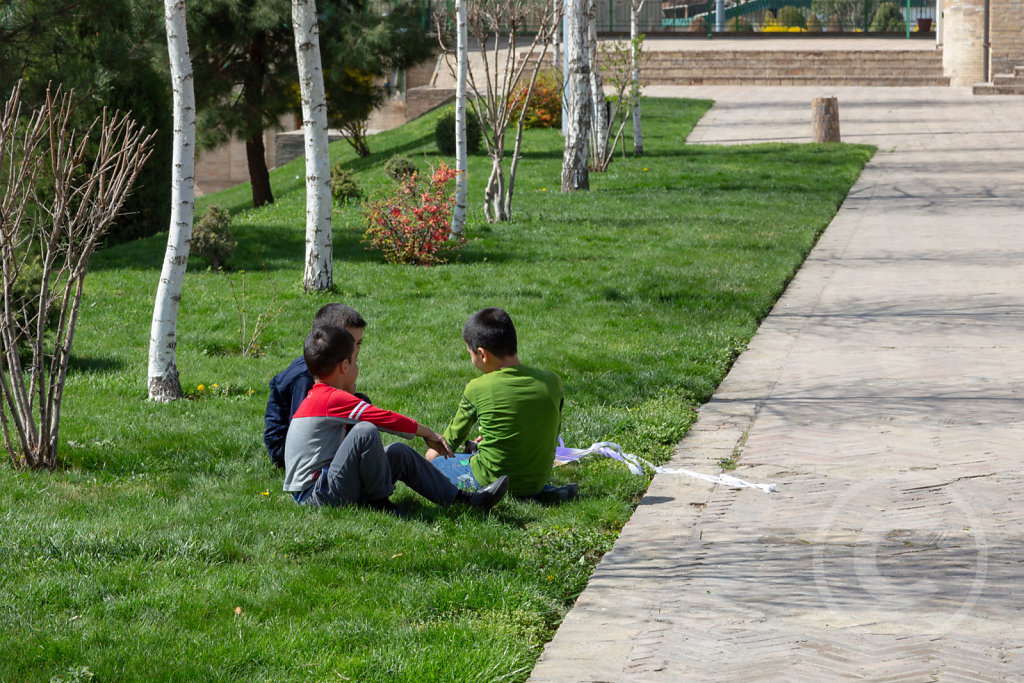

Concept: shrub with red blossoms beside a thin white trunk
[[362, 164, 458, 265]]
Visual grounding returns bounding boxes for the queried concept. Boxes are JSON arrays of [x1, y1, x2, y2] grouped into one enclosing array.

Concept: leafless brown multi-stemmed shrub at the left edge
[[0, 85, 153, 468]]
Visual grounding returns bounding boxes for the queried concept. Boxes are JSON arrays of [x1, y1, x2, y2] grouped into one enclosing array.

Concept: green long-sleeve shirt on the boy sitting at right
[[444, 366, 562, 496]]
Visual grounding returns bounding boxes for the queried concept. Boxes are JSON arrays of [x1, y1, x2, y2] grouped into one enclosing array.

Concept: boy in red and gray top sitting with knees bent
[[284, 326, 509, 512]]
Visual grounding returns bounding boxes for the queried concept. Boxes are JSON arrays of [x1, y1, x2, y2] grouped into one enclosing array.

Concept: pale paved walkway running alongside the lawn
[[531, 87, 1024, 683]]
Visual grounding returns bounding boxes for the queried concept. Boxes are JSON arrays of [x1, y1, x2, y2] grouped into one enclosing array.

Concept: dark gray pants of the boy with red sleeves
[[301, 422, 459, 507]]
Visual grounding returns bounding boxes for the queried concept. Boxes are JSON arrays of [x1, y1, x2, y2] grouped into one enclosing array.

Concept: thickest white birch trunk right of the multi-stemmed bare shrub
[[562, 0, 593, 193]]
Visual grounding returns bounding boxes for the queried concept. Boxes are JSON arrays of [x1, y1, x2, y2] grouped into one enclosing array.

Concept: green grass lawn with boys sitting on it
[[0, 99, 871, 682]]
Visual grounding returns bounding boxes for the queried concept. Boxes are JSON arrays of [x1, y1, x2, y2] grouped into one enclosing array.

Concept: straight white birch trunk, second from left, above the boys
[[292, 0, 334, 292]]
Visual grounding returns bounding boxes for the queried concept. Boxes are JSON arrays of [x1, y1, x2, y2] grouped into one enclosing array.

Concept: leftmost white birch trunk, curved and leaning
[[148, 0, 196, 401]]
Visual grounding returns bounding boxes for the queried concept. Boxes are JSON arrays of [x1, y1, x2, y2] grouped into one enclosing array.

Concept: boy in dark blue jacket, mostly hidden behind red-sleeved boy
[[263, 303, 370, 467]]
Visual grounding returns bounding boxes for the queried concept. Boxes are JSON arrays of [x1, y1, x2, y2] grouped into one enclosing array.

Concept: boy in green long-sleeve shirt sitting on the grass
[[427, 308, 575, 499]]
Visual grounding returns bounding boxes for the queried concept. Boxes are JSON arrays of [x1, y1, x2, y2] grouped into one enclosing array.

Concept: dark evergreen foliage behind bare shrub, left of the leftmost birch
[[0, 0, 172, 242]]
